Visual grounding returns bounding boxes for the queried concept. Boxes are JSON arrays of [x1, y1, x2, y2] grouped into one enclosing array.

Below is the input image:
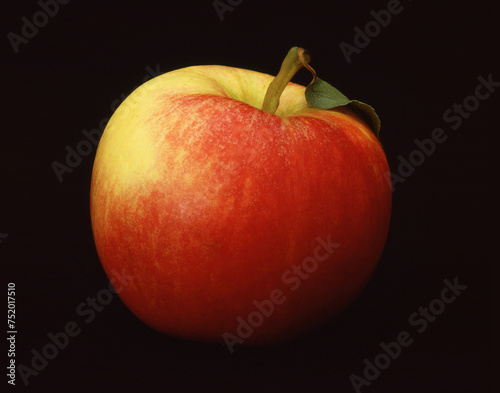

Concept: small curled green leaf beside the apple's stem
[[306, 78, 380, 138]]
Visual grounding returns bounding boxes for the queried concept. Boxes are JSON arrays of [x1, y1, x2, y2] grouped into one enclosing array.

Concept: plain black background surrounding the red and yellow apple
[[0, 0, 492, 393]]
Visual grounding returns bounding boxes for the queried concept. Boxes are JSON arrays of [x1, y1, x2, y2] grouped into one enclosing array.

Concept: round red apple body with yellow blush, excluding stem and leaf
[[91, 66, 392, 344]]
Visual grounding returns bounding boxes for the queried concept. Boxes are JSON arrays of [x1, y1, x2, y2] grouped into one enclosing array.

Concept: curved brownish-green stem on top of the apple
[[262, 46, 316, 114]]
